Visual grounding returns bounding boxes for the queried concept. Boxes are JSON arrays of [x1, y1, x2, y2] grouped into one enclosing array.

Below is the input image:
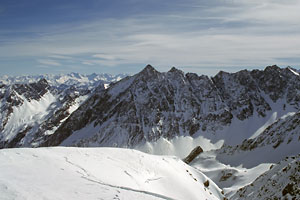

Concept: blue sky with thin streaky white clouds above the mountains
[[0, 0, 300, 76]]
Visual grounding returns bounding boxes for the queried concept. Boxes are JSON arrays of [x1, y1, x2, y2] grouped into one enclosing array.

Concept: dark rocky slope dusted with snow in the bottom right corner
[[231, 154, 300, 199]]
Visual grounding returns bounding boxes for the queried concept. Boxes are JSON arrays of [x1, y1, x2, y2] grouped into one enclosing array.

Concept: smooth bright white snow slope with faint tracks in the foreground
[[0, 147, 223, 200]]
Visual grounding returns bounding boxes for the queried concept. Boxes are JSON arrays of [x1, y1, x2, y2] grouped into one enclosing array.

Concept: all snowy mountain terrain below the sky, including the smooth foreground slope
[[0, 65, 300, 200]]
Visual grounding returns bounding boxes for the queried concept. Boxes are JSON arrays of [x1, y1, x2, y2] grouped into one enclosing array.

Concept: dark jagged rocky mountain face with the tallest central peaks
[[41, 65, 300, 147]]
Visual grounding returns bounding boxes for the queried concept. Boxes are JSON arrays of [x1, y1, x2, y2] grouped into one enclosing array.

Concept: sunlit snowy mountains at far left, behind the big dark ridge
[[0, 74, 125, 148]]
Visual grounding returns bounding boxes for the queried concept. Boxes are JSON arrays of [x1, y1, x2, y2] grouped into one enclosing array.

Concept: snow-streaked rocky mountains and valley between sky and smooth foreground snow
[[0, 65, 300, 199]]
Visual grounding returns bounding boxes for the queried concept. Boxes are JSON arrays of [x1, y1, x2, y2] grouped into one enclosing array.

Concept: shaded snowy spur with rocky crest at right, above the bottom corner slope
[[215, 112, 300, 168]]
